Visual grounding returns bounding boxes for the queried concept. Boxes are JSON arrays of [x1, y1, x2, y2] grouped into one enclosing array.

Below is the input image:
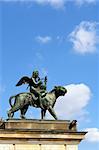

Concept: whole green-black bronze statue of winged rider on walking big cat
[[8, 71, 67, 119]]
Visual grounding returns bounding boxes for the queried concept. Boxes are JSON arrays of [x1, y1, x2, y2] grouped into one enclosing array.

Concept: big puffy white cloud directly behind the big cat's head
[[55, 83, 92, 119]]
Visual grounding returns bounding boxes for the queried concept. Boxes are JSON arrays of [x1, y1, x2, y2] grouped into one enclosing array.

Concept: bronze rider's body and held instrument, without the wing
[[30, 71, 47, 108]]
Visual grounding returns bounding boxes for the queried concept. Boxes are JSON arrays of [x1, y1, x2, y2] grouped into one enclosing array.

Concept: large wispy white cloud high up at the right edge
[[69, 21, 99, 54]]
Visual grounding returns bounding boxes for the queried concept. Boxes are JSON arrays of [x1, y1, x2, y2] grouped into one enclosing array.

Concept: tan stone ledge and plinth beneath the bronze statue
[[0, 120, 86, 150]]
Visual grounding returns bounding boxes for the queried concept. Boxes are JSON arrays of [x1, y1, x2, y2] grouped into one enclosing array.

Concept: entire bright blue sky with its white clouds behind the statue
[[0, 0, 99, 150]]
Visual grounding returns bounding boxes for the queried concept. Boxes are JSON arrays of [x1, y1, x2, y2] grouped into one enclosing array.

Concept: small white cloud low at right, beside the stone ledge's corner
[[85, 128, 99, 142]]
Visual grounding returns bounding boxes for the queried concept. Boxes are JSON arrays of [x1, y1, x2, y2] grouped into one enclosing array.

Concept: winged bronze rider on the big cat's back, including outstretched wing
[[16, 70, 47, 109]]
